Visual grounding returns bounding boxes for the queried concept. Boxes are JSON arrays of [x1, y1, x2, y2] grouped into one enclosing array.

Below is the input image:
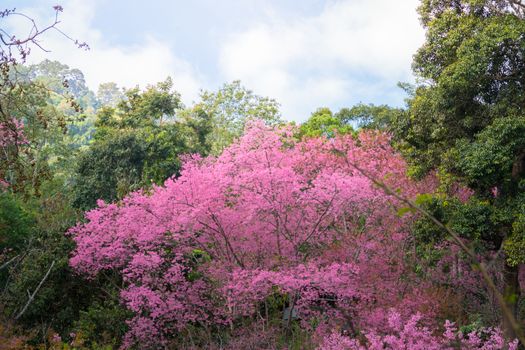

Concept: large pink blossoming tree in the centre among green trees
[[69, 123, 466, 347]]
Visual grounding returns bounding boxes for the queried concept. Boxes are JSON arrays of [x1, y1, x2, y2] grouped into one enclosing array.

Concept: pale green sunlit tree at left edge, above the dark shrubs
[[0, 75, 83, 195]]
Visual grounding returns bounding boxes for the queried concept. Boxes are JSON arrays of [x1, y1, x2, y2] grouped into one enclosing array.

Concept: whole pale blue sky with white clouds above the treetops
[[2, 0, 424, 121]]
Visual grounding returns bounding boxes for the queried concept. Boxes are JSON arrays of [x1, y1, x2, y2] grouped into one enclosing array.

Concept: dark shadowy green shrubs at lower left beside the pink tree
[[0, 179, 127, 345]]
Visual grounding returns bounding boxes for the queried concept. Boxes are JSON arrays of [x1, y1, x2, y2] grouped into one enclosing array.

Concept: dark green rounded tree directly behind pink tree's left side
[[74, 78, 211, 209]]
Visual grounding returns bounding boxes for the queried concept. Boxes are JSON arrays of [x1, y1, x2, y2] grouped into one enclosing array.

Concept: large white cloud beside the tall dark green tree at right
[[219, 0, 424, 120]]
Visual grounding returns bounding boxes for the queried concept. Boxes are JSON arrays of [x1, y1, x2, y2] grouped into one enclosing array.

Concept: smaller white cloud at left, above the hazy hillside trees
[[6, 0, 203, 103]]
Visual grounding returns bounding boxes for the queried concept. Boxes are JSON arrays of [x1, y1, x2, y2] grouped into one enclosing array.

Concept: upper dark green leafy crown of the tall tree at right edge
[[400, 0, 525, 178]]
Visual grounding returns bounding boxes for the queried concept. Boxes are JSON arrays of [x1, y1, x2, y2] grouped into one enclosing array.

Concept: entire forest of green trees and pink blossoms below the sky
[[0, 0, 525, 350]]
